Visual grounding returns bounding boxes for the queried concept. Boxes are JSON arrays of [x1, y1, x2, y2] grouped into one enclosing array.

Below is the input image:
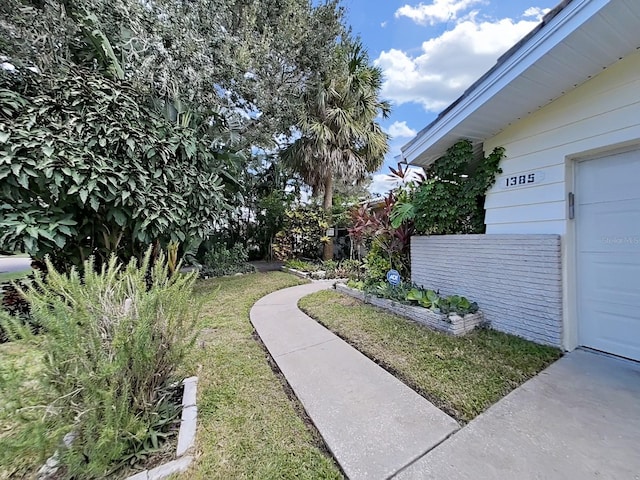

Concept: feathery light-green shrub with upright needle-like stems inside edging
[[0, 251, 198, 478]]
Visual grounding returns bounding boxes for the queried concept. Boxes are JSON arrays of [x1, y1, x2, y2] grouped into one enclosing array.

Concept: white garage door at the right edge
[[575, 146, 640, 360]]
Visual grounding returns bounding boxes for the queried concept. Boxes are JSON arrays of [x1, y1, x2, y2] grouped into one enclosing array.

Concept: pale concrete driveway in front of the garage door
[[393, 350, 640, 480]]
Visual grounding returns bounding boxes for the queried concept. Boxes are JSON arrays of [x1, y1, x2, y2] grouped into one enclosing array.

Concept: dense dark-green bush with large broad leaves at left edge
[[0, 64, 238, 268]]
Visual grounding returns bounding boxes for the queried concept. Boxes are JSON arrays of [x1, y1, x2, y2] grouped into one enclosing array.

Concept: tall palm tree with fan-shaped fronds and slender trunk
[[282, 41, 390, 260]]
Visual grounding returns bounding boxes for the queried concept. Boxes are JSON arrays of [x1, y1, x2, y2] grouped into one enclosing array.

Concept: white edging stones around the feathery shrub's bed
[[38, 377, 198, 480]]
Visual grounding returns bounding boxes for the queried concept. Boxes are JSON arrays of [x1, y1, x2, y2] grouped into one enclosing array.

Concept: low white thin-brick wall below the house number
[[411, 235, 562, 347]]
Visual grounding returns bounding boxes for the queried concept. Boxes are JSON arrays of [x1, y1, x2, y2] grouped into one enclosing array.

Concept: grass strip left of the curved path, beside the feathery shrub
[[184, 272, 342, 479]]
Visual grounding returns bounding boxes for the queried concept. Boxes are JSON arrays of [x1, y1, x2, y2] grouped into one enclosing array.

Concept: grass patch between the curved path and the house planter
[[299, 290, 561, 423]]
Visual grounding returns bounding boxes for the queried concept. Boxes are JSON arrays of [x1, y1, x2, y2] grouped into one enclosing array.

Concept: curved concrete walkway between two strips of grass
[[250, 281, 459, 480]]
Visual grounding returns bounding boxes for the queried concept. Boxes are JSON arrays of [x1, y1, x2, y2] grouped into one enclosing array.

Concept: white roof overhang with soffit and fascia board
[[402, 0, 640, 166]]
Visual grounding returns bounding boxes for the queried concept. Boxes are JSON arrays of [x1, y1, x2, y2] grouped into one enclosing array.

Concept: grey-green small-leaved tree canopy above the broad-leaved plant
[[0, 0, 345, 145]]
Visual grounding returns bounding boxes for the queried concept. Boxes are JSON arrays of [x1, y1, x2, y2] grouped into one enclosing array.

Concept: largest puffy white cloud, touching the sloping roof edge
[[376, 9, 541, 112]]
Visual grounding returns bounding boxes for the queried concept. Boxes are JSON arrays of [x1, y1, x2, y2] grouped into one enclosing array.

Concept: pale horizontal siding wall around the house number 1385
[[484, 52, 640, 234]]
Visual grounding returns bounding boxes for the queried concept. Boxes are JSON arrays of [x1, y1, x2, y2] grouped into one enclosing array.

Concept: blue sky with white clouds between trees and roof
[[342, 0, 559, 193]]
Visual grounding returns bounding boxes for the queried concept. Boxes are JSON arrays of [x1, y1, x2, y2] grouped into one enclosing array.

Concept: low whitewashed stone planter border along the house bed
[[336, 283, 484, 335]]
